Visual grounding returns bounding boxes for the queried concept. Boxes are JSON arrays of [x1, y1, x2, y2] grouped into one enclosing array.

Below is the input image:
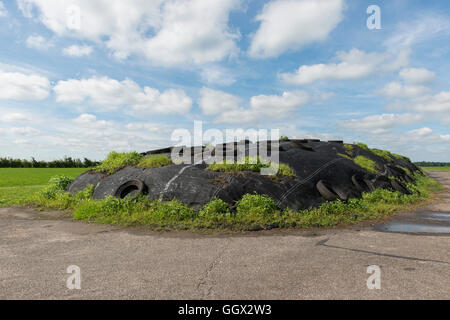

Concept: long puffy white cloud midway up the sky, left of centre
[[54, 77, 192, 114]]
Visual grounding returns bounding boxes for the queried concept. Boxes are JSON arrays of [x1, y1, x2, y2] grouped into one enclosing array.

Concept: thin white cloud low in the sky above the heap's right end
[[340, 113, 422, 134]]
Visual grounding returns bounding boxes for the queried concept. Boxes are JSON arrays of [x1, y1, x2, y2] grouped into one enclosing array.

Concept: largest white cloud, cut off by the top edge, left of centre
[[18, 0, 240, 65]]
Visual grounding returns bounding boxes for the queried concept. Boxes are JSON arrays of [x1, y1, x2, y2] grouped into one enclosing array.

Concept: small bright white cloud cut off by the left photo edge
[[0, 69, 50, 100]]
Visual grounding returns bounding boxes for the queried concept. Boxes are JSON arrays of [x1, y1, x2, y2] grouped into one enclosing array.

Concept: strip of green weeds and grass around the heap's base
[[6, 171, 442, 230]]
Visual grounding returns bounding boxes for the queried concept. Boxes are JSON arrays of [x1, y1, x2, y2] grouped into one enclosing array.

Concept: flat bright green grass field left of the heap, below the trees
[[0, 168, 88, 206]]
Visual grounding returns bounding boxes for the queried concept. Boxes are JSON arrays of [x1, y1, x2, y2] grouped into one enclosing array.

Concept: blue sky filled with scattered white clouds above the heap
[[0, 0, 450, 161]]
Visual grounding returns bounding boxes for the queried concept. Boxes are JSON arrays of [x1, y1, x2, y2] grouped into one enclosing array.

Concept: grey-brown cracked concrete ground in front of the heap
[[0, 172, 450, 299]]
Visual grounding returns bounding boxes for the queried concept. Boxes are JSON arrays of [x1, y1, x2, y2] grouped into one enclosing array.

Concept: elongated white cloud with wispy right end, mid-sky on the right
[[280, 48, 404, 85]]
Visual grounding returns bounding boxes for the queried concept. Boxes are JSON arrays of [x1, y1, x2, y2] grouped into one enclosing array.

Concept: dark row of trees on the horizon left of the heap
[[0, 157, 100, 168]]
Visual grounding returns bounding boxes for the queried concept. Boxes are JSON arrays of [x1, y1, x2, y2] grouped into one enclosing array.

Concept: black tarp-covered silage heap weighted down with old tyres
[[68, 140, 420, 210]]
